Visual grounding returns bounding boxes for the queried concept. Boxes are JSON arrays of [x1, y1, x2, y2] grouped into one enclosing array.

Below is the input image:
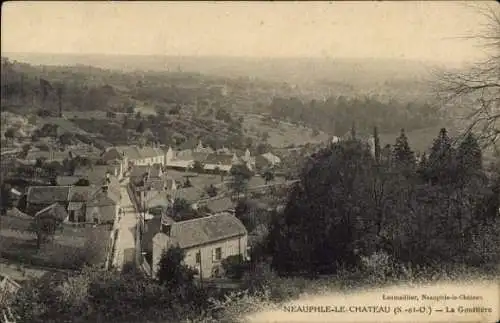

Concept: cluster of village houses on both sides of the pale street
[[2, 142, 281, 294]]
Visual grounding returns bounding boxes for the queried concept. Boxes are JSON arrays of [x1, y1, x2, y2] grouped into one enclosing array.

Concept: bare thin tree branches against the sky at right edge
[[435, 5, 500, 146]]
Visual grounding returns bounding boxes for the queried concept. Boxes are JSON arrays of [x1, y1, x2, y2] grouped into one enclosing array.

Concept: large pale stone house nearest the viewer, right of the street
[[151, 213, 248, 279]]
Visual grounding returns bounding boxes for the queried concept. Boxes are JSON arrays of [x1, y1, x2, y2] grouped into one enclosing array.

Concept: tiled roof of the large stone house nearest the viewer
[[155, 213, 247, 249]]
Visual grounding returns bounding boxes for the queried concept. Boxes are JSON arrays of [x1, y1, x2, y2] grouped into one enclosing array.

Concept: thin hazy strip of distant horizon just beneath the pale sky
[[1, 51, 474, 64]]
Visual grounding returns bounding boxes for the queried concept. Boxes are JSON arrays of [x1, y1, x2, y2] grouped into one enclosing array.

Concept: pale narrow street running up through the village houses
[[113, 178, 138, 270]]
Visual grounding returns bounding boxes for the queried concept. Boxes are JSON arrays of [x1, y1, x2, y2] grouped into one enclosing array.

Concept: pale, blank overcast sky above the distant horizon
[[1, 1, 495, 62]]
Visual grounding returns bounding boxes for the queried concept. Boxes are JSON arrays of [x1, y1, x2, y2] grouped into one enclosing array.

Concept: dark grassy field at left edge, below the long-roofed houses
[[0, 216, 111, 269]]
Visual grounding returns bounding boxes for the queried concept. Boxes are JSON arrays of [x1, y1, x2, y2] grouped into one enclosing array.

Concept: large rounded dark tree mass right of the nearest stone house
[[269, 140, 375, 276]]
